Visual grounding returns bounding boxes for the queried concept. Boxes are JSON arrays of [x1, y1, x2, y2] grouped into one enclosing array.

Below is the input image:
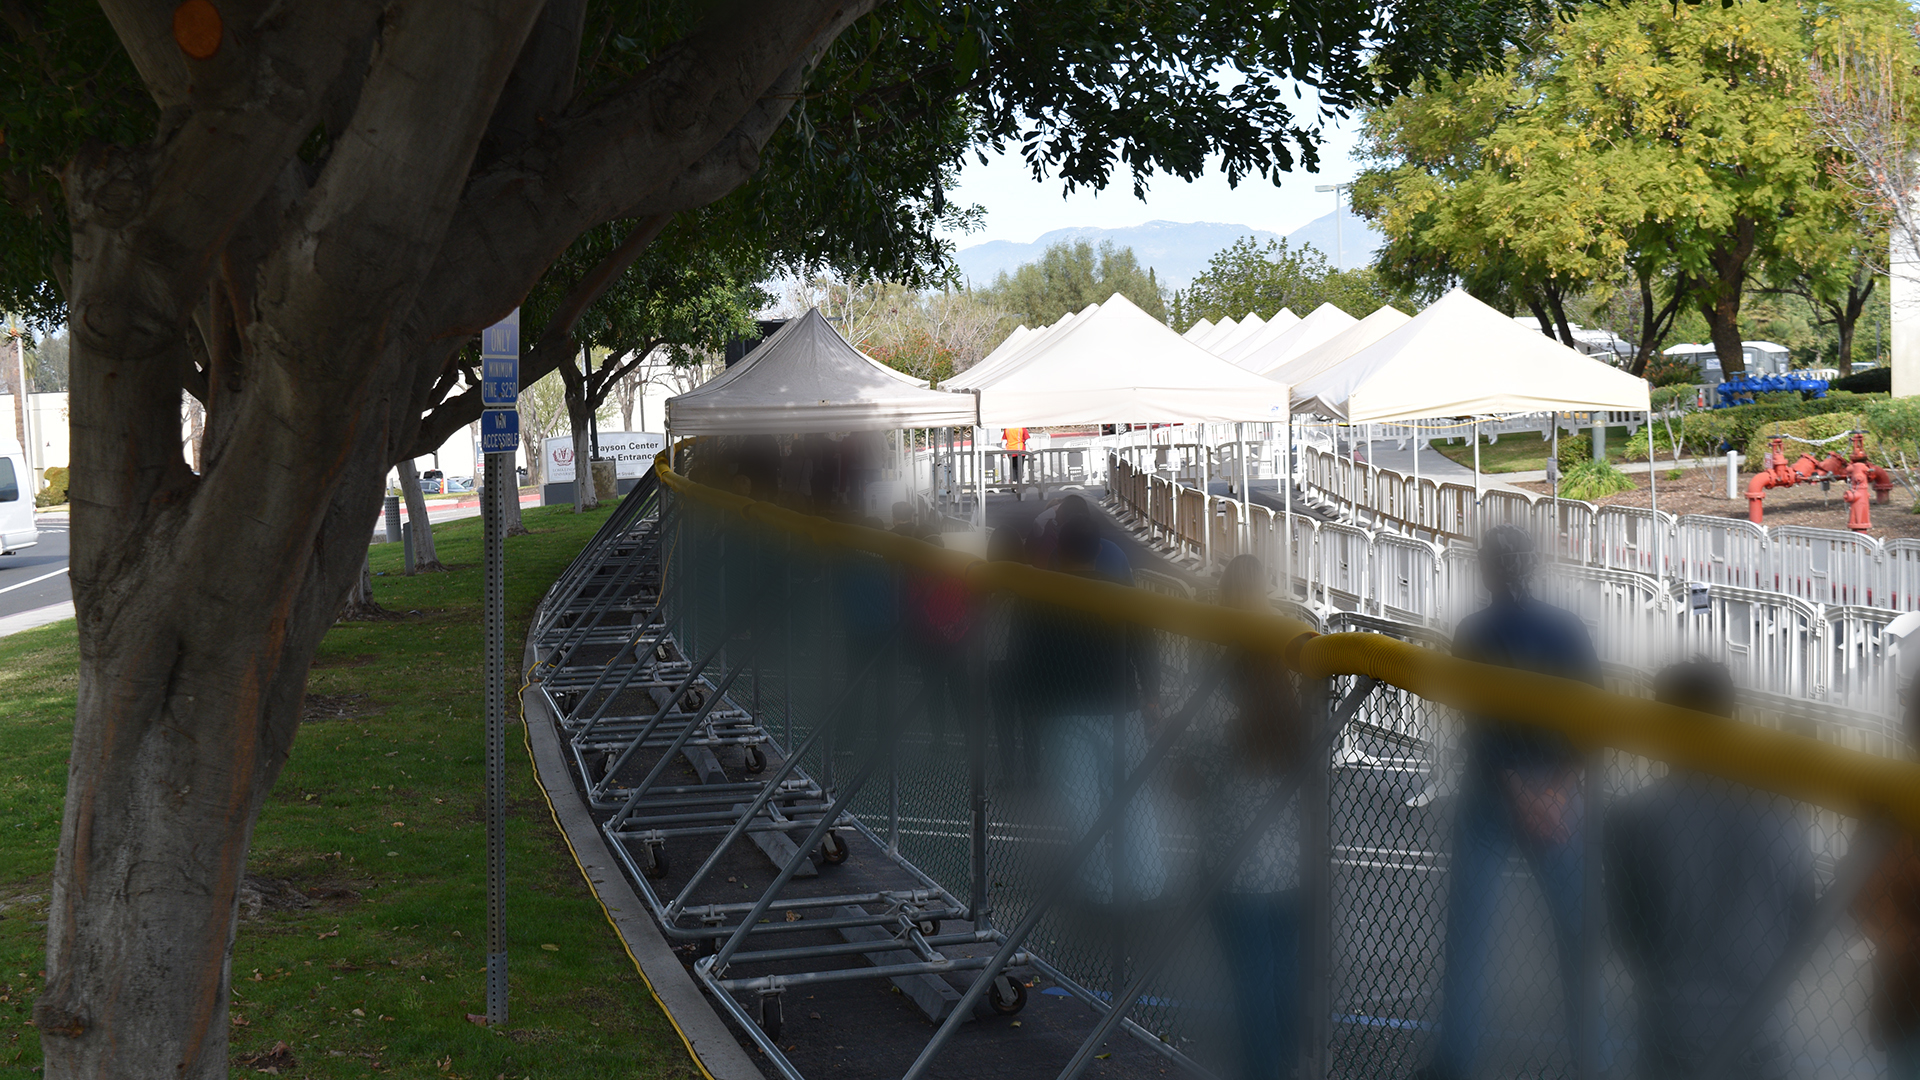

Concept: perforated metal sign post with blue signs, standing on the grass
[[480, 307, 520, 1024]]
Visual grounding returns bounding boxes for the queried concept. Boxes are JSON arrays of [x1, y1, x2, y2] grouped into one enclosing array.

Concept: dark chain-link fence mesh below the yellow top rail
[[556, 472, 1920, 1080]]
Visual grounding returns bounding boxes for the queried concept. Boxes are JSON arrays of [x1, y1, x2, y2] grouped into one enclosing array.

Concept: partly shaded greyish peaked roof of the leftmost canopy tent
[[666, 309, 979, 436]]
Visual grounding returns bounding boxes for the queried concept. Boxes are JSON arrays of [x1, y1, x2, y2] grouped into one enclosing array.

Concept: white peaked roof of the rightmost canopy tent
[[1294, 288, 1651, 423]]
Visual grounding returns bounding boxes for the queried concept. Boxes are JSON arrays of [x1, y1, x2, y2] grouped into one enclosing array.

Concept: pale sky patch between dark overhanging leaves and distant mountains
[[947, 121, 1359, 248]]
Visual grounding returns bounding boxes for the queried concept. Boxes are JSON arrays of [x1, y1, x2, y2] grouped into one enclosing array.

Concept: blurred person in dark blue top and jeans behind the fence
[[1419, 525, 1601, 1080]]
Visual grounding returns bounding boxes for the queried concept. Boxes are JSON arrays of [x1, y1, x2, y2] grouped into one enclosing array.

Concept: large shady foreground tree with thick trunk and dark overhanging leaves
[[0, 0, 1542, 1060]]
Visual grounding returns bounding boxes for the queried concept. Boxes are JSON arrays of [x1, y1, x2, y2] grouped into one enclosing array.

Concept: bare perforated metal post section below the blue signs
[[484, 454, 513, 1024]]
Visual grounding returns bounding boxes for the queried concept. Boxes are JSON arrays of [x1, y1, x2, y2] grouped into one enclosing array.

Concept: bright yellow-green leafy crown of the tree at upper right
[[1356, 0, 1895, 373]]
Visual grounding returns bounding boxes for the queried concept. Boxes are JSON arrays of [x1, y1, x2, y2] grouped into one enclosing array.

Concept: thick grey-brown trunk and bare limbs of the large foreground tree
[[35, 0, 872, 1080]]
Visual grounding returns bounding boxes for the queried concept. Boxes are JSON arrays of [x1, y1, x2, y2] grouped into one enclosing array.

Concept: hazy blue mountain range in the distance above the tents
[[954, 213, 1382, 288]]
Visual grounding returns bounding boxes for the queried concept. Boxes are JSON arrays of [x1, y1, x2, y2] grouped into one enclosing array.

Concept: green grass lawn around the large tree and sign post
[[0, 507, 699, 1080]]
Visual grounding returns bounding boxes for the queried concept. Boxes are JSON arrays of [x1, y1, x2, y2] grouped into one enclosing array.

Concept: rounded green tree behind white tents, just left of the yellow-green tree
[[1171, 236, 1409, 332]]
